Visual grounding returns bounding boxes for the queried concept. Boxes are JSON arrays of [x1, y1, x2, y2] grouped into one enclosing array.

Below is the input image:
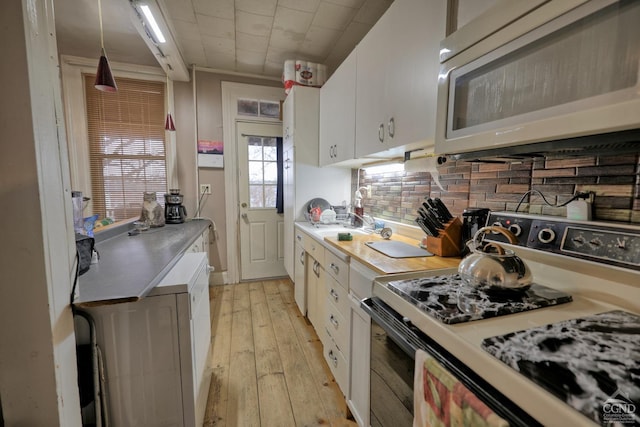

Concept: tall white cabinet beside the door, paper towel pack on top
[[282, 86, 351, 280]]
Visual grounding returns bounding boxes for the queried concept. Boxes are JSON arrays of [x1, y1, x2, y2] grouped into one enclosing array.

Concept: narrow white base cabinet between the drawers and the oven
[[347, 260, 375, 427]]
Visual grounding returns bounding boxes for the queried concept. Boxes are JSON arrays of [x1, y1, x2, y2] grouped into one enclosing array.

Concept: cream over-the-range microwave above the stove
[[435, 0, 640, 158]]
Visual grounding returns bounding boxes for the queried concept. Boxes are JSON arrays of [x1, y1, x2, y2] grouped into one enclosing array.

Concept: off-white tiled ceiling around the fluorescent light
[[54, 0, 393, 78]]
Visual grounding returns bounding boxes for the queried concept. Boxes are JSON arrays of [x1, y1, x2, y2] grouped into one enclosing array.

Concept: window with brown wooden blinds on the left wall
[[84, 75, 167, 221]]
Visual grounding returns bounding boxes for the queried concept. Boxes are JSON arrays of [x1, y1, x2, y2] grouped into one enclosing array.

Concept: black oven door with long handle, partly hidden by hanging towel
[[361, 297, 540, 427]]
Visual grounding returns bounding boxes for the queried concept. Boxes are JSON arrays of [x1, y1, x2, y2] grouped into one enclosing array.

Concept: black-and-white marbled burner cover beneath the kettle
[[387, 274, 572, 324]]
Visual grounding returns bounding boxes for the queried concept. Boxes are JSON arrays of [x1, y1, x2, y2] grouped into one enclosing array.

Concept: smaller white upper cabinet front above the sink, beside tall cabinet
[[319, 50, 356, 166]]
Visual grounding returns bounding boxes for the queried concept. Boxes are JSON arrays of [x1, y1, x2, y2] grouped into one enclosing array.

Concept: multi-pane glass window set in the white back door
[[248, 136, 278, 208]]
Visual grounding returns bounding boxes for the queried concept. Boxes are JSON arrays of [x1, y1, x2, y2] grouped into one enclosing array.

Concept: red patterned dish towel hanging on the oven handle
[[413, 350, 509, 427]]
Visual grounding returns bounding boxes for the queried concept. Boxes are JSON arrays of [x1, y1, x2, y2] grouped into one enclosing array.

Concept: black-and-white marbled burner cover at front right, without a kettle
[[482, 310, 640, 427]]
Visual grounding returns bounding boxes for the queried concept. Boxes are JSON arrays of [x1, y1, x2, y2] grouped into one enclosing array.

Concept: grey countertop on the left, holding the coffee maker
[[74, 219, 211, 307]]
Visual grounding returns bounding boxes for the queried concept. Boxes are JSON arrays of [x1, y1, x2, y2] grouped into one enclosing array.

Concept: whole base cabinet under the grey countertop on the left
[[86, 253, 211, 427]]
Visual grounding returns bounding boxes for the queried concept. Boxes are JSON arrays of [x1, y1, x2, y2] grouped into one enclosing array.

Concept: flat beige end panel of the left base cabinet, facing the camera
[[89, 294, 188, 427]]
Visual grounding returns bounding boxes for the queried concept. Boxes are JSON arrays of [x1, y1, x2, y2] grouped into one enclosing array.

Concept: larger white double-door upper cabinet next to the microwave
[[355, 0, 447, 158]]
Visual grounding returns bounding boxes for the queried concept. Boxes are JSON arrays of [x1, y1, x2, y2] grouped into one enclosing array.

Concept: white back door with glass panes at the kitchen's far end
[[236, 122, 287, 280]]
